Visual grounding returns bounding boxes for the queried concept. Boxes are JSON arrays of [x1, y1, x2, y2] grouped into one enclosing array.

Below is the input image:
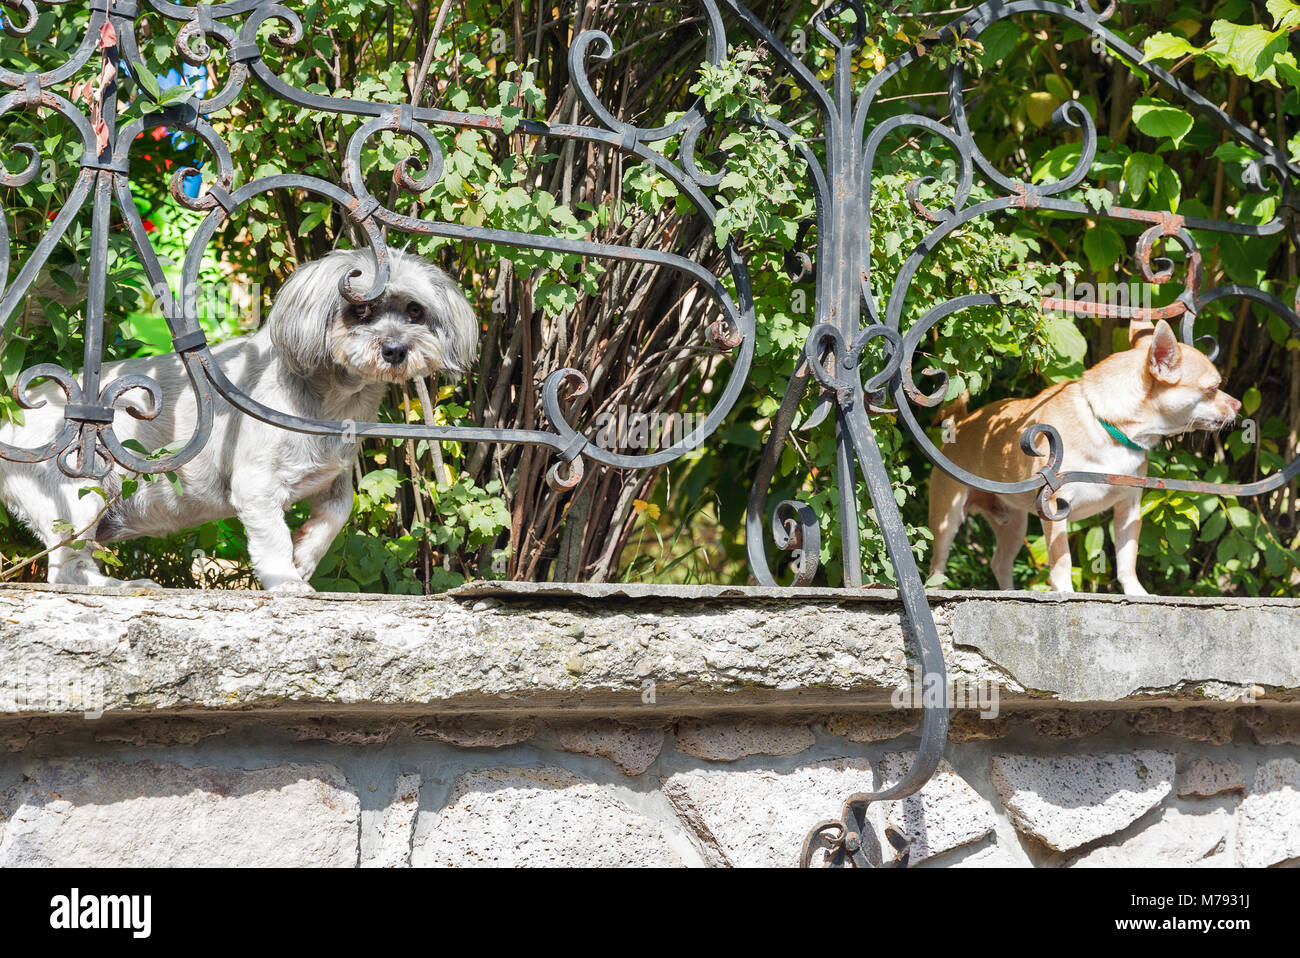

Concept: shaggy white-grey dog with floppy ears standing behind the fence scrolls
[[0, 251, 478, 591]]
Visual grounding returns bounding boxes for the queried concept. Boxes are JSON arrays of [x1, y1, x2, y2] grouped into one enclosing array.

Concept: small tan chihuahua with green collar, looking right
[[930, 320, 1242, 595]]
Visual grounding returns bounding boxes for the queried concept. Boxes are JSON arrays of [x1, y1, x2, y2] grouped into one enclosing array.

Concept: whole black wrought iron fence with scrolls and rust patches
[[0, 0, 1300, 864]]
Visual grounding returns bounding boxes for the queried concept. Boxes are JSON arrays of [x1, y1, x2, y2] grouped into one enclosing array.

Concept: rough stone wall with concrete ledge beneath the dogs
[[0, 586, 1300, 867]]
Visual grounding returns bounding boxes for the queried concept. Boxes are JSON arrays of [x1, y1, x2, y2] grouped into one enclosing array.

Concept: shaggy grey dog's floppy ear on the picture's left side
[[267, 251, 355, 376]]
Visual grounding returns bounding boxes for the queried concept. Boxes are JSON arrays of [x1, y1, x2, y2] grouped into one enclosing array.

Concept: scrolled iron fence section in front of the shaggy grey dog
[[0, 0, 755, 489]]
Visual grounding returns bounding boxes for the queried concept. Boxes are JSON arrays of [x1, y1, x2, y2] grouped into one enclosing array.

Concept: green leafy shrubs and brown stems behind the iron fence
[[0, 0, 1300, 594]]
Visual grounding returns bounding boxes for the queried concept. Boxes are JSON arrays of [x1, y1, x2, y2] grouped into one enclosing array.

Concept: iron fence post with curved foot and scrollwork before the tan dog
[[723, 0, 1300, 867]]
